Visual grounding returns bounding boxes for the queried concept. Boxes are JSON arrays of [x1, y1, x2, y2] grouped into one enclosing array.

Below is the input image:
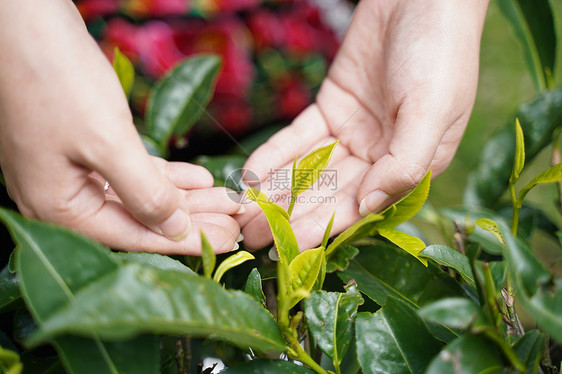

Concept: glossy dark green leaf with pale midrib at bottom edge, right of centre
[[355, 298, 441, 374]]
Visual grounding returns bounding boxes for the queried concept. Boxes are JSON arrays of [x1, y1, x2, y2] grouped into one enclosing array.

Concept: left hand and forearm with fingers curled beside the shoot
[[0, 0, 240, 254]]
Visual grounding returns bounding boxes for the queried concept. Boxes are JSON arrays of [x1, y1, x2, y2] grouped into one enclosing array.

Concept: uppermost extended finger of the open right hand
[[244, 104, 329, 184]]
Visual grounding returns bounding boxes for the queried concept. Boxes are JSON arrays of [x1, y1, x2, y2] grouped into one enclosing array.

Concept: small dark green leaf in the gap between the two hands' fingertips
[[194, 155, 246, 192]]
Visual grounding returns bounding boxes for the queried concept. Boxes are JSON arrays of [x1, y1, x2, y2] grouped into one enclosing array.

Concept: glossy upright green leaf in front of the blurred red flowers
[[146, 56, 220, 154]]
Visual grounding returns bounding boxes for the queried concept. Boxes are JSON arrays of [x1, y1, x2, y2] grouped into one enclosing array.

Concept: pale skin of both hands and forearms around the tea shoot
[[0, 0, 488, 254]]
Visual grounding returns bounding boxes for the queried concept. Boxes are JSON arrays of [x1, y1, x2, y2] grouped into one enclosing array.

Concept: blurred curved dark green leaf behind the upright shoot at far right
[[464, 89, 562, 208]]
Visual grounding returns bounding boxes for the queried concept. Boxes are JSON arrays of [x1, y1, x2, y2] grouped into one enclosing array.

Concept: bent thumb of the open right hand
[[357, 114, 442, 216]]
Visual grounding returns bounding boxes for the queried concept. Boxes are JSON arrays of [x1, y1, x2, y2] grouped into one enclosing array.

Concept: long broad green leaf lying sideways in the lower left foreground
[[30, 264, 285, 352]]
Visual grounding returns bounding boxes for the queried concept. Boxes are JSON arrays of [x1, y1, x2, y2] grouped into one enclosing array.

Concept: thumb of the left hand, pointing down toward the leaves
[[94, 134, 191, 240]]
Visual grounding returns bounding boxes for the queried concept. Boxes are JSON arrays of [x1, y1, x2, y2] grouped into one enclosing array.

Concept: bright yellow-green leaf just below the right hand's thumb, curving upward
[[380, 170, 431, 228]]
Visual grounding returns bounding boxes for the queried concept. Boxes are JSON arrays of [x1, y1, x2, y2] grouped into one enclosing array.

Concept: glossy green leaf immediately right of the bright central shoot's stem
[[304, 286, 363, 367]]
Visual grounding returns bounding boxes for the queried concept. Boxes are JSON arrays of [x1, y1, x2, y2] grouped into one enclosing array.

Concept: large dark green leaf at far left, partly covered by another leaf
[[0, 209, 159, 374]]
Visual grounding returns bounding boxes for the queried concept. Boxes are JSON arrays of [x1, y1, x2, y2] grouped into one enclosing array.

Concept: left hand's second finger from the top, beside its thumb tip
[[184, 187, 245, 215]]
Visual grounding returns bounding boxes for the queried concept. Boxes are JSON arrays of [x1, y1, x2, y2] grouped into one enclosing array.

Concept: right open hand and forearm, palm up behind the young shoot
[[238, 0, 488, 250]]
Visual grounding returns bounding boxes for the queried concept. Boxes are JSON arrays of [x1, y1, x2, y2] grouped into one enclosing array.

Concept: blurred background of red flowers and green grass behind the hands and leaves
[[75, 0, 562, 225]]
